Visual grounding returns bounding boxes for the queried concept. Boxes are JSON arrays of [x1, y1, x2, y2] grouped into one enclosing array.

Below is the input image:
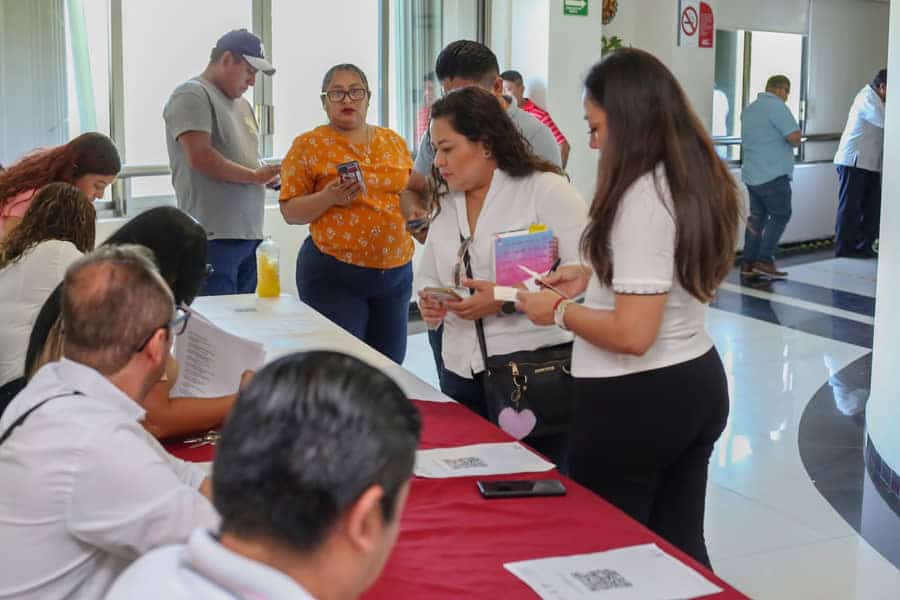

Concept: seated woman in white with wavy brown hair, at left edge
[[0, 183, 96, 398]]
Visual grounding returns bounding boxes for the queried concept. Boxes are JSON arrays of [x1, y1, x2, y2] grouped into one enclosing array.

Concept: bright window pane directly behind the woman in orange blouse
[[272, 0, 382, 156]]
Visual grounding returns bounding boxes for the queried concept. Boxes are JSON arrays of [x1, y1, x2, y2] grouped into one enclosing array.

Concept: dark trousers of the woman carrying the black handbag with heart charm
[[428, 326, 569, 474]]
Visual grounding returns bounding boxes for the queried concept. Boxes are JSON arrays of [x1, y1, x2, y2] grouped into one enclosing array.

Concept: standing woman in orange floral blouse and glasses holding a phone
[[281, 64, 413, 363]]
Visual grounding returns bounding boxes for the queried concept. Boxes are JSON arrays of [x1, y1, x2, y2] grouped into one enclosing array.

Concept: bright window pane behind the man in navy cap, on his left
[[122, 0, 253, 207]]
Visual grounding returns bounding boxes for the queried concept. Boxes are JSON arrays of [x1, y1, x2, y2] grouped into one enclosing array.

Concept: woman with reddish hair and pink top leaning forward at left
[[0, 132, 122, 239]]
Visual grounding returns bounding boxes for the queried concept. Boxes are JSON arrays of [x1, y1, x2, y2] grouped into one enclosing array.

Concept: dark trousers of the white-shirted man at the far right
[[834, 165, 881, 256]]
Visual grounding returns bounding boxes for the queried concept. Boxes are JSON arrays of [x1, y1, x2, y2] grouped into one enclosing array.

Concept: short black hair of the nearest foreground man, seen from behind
[[212, 351, 421, 552]]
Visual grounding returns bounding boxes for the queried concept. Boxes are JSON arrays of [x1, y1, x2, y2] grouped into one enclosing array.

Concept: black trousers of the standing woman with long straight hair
[[569, 348, 728, 566]]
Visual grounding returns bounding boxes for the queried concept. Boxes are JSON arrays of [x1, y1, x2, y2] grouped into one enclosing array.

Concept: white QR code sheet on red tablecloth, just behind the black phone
[[413, 442, 554, 479]]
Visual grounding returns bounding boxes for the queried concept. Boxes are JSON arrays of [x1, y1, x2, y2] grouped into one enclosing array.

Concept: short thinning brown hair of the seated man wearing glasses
[[62, 245, 175, 375]]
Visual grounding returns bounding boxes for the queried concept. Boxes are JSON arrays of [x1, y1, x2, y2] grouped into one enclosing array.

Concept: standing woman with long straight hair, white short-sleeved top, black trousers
[[520, 49, 740, 565]]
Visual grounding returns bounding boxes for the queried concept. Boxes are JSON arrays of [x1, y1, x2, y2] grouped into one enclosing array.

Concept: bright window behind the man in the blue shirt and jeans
[[712, 30, 805, 160]]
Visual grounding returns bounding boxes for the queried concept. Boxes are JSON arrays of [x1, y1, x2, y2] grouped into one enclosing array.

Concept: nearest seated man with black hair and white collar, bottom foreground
[[107, 352, 420, 600]]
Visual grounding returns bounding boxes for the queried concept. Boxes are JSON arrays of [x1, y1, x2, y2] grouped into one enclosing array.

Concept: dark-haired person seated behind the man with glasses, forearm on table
[[25, 206, 243, 439]]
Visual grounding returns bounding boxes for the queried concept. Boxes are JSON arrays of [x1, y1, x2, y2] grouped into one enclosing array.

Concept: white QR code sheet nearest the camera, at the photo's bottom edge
[[503, 544, 722, 600]]
